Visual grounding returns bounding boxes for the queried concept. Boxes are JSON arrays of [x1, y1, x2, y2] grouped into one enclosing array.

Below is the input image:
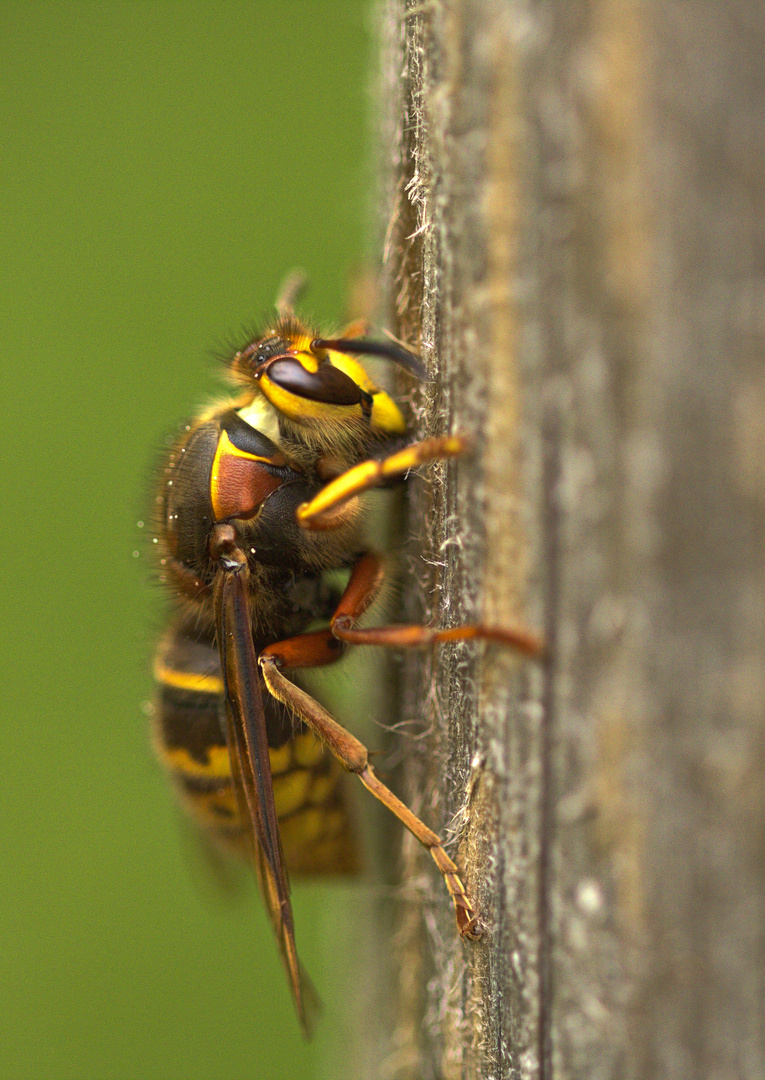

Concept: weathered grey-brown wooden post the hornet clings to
[[361, 0, 765, 1080]]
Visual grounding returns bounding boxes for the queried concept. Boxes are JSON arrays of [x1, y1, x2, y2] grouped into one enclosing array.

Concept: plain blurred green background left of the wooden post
[[0, 0, 380, 1080]]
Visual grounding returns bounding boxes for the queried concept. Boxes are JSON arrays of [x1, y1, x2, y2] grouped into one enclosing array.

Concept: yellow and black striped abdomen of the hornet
[[155, 622, 358, 874]]
